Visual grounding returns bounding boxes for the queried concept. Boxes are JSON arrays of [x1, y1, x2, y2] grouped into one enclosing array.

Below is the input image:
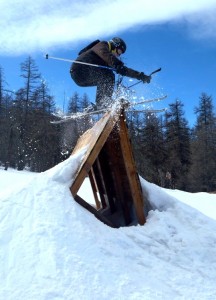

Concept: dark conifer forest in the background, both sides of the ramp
[[0, 57, 216, 192]]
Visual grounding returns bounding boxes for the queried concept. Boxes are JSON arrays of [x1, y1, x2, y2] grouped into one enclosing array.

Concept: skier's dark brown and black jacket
[[72, 41, 140, 79]]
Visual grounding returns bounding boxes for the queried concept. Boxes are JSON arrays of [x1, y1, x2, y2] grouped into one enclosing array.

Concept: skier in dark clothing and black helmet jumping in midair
[[70, 37, 151, 109]]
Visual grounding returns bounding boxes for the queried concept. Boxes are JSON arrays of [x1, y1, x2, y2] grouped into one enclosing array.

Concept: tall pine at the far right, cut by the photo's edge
[[190, 93, 216, 192]]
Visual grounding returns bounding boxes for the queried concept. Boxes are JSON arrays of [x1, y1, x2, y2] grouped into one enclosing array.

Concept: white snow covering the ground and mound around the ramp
[[0, 151, 216, 300]]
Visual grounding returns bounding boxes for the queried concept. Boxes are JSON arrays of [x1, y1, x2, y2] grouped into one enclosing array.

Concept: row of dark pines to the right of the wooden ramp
[[128, 93, 216, 192]]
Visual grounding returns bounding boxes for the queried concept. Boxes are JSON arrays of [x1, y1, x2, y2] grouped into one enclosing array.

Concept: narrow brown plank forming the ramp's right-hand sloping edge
[[119, 111, 145, 225]]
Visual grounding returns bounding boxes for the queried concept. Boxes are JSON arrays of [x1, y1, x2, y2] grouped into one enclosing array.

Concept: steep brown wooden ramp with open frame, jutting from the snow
[[70, 102, 145, 228]]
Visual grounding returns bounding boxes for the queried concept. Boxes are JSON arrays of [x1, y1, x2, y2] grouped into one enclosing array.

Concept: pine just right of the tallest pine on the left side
[[28, 81, 59, 172]]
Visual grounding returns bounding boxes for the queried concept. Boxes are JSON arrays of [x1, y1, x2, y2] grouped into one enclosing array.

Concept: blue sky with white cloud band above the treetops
[[0, 0, 216, 124]]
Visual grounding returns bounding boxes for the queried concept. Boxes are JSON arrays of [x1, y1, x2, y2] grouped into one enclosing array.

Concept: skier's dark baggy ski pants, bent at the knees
[[70, 63, 115, 107]]
